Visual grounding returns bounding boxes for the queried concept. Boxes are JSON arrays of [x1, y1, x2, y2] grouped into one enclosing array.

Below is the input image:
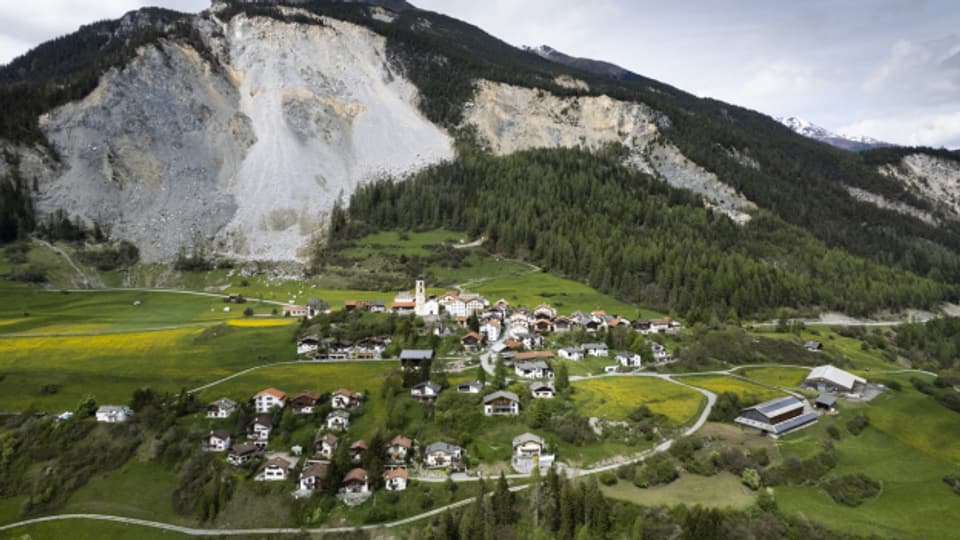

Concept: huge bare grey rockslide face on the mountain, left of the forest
[[28, 8, 452, 261]]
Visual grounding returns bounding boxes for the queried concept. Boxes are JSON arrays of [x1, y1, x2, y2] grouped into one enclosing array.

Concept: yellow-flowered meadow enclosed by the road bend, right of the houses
[[572, 376, 706, 425]]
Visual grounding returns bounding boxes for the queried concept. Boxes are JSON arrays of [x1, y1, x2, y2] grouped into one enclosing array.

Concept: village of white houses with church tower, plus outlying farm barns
[[88, 279, 883, 505]]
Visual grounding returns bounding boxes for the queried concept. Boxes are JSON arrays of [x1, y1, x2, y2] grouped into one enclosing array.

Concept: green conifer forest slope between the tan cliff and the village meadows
[[342, 144, 953, 321]]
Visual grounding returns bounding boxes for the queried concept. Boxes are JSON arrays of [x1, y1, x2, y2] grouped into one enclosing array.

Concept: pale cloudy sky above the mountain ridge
[[0, 0, 960, 148]]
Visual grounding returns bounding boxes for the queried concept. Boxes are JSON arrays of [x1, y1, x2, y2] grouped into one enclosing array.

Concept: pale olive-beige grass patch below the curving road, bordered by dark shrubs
[[601, 472, 756, 510]]
